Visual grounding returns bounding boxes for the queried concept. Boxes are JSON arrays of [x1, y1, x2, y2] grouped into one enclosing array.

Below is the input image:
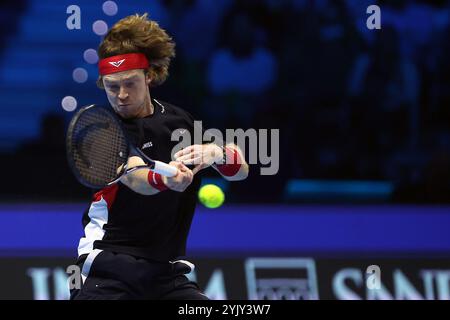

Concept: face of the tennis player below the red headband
[[103, 70, 151, 118]]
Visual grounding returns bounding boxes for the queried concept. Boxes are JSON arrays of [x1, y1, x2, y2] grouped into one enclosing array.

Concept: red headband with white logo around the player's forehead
[[98, 53, 149, 76]]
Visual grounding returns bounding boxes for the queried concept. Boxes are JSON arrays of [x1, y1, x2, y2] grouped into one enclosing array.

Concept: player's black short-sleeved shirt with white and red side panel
[[78, 100, 201, 262]]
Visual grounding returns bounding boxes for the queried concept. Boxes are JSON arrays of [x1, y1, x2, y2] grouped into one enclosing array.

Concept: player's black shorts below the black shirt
[[70, 250, 208, 300]]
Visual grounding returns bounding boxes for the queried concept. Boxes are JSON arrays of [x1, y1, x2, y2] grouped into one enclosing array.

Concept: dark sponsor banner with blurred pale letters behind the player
[[0, 256, 450, 300]]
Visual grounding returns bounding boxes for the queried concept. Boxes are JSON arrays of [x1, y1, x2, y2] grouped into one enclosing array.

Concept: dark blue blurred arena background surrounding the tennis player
[[0, 0, 450, 300]]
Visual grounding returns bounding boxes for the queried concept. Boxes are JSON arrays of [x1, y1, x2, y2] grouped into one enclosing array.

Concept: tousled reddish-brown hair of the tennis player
[[97, 13, 175, 88]]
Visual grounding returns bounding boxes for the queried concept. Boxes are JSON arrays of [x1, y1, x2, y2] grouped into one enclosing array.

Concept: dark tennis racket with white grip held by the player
[[66, 105, 178, 189]]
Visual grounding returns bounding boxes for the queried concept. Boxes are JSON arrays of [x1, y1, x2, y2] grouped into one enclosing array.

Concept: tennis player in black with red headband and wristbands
[[71, 14, 248, 300]]
